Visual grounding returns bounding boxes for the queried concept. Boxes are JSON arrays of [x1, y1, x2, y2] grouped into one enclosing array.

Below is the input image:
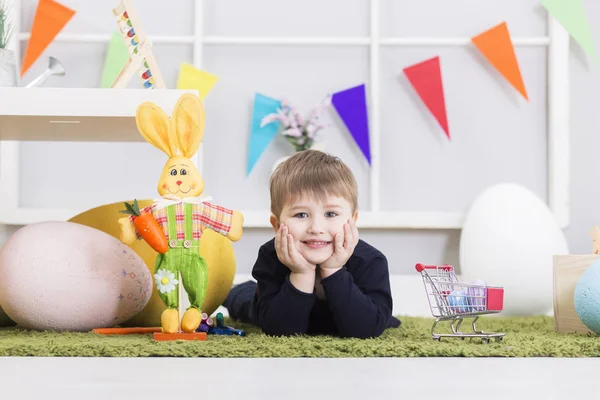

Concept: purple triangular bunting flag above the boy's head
[[331, 84, 371, 164]]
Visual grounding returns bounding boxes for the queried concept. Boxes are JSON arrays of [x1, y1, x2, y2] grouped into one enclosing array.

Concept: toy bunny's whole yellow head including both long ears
[[135, 93, 209, 198]]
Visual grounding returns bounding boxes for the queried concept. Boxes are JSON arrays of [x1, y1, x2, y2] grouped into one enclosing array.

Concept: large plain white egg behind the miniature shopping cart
[[459, 183, 568, 315]]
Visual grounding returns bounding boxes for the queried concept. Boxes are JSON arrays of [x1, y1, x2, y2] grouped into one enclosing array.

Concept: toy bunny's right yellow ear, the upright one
[[172, 93, 205, 158]]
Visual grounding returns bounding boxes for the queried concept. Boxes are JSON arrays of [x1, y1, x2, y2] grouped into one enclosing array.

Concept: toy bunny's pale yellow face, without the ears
[[158, 157, 204, 198]]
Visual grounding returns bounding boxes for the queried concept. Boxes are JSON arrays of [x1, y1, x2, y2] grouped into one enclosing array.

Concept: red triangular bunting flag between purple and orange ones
[[403, 56, 450, 139]]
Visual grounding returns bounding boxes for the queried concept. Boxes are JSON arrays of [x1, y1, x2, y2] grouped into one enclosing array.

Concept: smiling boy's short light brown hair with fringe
[[270, 150, 358, 219]]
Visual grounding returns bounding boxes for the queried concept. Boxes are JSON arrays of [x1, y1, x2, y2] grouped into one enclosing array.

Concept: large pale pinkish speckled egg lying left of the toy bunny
[[0, 221, 152, 331]]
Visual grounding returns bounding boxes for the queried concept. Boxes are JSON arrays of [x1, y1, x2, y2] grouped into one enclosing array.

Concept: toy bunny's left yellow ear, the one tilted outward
[[135, 101, 177, 157]]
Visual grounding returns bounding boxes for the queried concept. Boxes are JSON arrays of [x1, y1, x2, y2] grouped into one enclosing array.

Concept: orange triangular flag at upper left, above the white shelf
[[21, 0, 75, 76]]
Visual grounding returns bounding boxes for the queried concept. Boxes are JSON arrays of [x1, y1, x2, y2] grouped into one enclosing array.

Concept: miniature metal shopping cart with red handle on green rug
[[416, 264, 505, 343]]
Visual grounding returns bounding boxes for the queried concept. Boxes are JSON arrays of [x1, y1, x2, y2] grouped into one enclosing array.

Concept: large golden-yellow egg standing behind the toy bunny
[[69, 200, 236, 326]]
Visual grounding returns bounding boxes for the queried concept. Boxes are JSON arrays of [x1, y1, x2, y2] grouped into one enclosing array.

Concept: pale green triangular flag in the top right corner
[[542, 0, 597, 61]]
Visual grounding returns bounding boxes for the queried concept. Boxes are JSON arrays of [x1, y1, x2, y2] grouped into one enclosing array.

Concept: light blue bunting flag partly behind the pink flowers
[[247, 93, 281, 175]]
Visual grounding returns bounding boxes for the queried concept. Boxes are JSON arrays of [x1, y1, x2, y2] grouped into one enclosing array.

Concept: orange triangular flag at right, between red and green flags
[[471, 22, 529, 101]]
